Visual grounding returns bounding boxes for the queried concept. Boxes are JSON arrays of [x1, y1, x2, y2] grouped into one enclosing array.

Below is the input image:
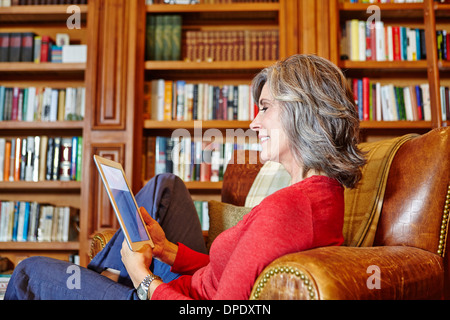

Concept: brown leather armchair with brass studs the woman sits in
[[92, 128, 450, 300]]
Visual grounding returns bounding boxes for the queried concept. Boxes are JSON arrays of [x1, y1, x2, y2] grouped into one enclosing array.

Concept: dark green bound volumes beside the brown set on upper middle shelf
[[145, 14, 182, 60]]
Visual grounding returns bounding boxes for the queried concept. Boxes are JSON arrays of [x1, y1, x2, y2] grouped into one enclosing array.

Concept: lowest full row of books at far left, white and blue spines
[[0, 201, 79, 242]]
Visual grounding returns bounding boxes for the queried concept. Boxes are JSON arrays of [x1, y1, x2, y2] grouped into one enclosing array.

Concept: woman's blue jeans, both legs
[[5, 174, 206, 300]]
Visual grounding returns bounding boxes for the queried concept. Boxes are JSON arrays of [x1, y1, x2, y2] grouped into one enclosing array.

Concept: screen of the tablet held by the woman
[[101, 164, 149, 242]]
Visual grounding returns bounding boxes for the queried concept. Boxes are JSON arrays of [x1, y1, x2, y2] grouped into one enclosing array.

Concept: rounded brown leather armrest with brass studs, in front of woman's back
[[250, 246, 444, 300]]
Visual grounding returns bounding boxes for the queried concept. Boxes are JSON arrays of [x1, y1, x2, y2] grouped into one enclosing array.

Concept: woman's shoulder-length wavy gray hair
[[252, 55, 366, 188]]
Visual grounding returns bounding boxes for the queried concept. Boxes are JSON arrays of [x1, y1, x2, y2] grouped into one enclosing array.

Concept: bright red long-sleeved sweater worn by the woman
[[152, 176, 344, 300]]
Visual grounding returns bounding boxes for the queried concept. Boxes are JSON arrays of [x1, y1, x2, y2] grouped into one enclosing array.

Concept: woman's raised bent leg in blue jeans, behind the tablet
[[88, 174, 206, 285]]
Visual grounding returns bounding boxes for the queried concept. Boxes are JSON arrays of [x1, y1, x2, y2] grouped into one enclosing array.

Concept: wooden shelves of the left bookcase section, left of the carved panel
[[0, 5, 88, 264]]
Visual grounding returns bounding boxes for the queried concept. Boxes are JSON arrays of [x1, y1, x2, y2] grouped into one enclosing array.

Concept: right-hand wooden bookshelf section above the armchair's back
[[330, 0, 448, 140]]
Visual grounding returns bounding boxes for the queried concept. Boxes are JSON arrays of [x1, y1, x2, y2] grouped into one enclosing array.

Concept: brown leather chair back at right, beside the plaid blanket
[[374, 128, 450, 298]]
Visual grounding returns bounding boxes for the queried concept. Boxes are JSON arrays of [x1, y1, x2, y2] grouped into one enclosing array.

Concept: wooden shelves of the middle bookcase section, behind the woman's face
[[139, 0, 298, 200]]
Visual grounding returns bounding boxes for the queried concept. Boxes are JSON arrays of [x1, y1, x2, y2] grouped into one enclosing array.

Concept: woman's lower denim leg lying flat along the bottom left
[[5, 257, 138, 300]]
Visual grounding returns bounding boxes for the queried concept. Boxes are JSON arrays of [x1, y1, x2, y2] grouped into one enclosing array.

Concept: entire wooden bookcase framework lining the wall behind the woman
[[0, 0, 450, 265]]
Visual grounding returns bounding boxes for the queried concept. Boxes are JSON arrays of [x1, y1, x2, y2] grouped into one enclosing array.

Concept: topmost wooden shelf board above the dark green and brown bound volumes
[[146, 2, 280, 13]]
